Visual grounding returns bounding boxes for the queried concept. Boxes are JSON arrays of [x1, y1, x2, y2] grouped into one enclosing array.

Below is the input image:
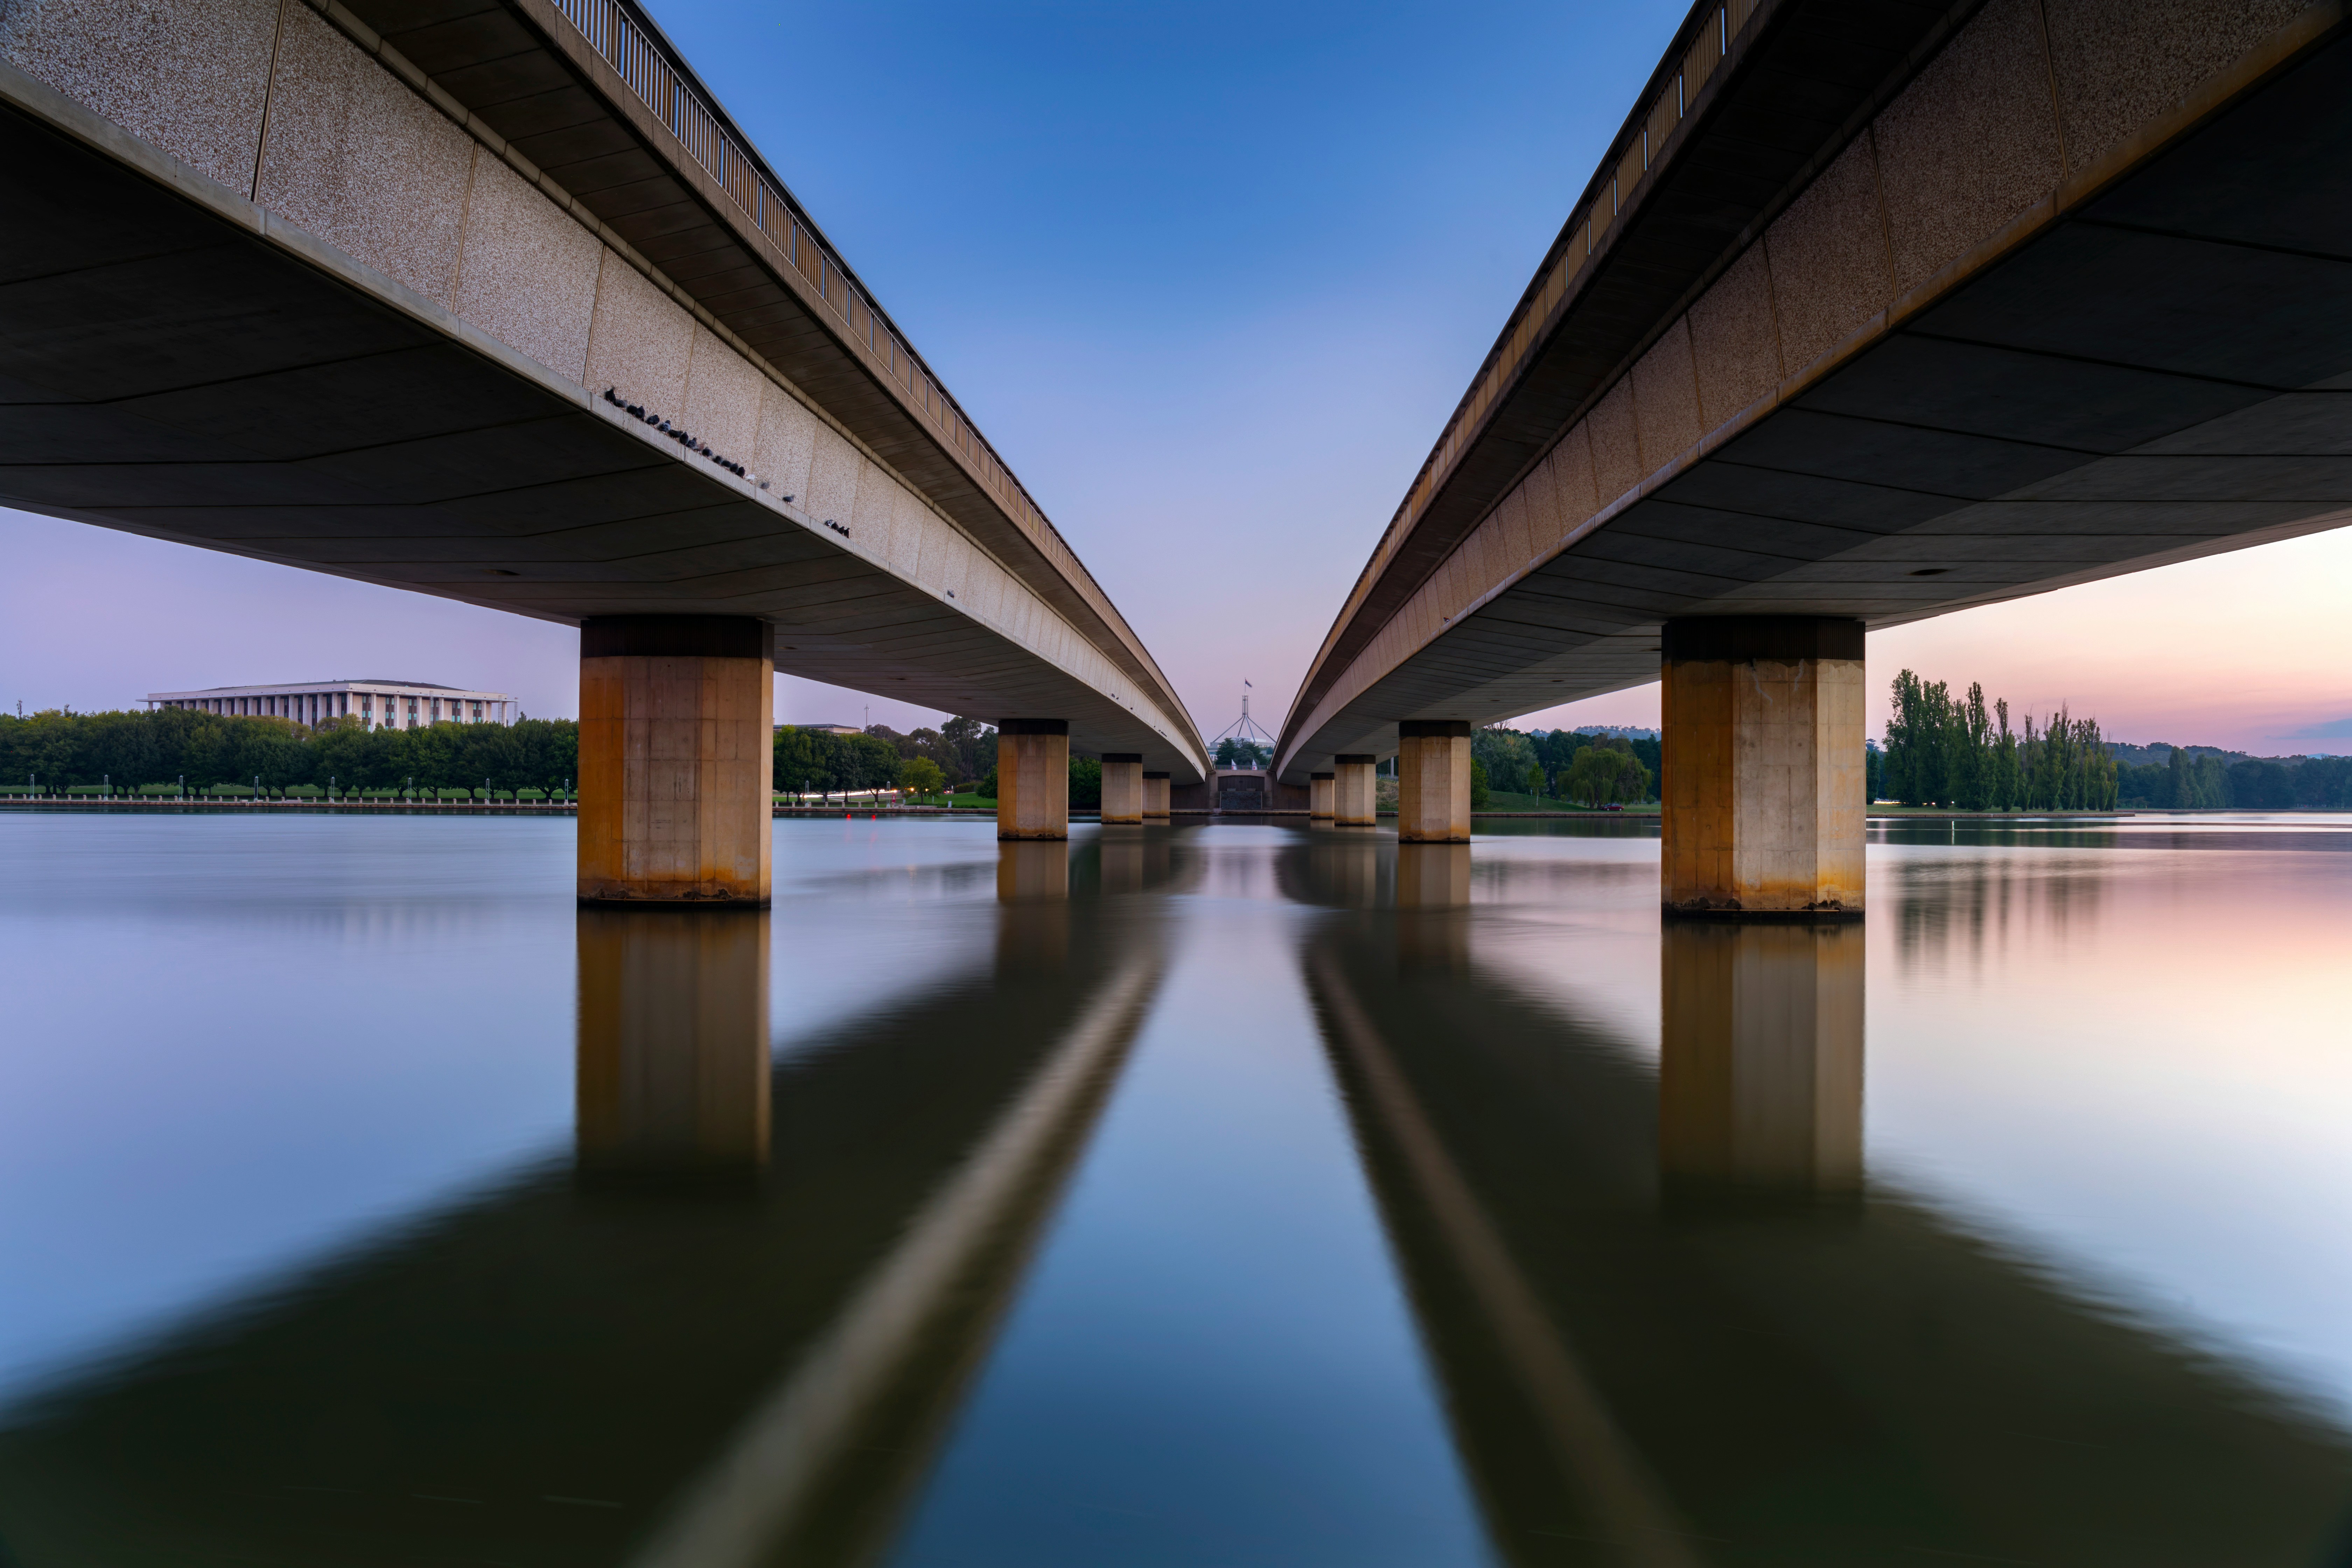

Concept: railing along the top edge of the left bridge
[[553, 0, 1117, 658]]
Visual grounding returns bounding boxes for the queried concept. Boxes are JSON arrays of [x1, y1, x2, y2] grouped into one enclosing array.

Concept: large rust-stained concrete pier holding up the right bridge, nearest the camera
[[1658, 616, 1865, 917]]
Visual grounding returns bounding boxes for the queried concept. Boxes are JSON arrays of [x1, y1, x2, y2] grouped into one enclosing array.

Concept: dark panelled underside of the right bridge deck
[[1277, 21, 2352, 783]]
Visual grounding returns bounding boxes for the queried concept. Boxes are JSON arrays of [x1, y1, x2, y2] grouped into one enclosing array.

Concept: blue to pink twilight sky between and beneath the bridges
[[0, 0, 2352, 752]]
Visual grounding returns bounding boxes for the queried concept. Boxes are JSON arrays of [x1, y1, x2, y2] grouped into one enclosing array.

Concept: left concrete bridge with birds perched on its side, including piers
[[0, 0, 1209, 900]]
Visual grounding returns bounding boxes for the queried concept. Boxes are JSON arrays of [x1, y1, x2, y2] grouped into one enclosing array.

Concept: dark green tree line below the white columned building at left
[[0, 708, 581, 792]]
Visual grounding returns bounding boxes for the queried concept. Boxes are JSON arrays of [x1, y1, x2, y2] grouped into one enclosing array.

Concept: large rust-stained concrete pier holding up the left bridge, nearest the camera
[[579, 616, 776, 905]]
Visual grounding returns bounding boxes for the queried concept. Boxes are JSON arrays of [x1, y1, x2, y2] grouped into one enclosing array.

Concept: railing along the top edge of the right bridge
[[1357, 0, 1764, 621]]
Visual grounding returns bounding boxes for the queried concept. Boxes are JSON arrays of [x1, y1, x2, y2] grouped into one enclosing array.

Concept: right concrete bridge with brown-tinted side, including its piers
[[1275, 0, 2352, 915]]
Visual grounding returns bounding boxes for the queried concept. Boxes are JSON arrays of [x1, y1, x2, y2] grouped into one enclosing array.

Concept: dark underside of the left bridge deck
[[0, 78, 1199, 780]]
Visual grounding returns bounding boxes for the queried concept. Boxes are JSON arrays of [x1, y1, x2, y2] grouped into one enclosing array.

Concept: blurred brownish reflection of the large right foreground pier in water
[[1658, 919, 1863, 1199]]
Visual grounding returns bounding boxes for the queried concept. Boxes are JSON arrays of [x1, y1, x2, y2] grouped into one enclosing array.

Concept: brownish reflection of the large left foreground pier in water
[[576, 905, 769, 1175]]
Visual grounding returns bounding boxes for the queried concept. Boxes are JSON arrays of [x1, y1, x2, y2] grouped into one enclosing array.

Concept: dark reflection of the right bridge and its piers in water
[[1284, 842, 2352, 1568]]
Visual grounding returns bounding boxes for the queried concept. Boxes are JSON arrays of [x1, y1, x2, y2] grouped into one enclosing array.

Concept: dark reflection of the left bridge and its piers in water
[[0, 870, 1167, 1568]]
